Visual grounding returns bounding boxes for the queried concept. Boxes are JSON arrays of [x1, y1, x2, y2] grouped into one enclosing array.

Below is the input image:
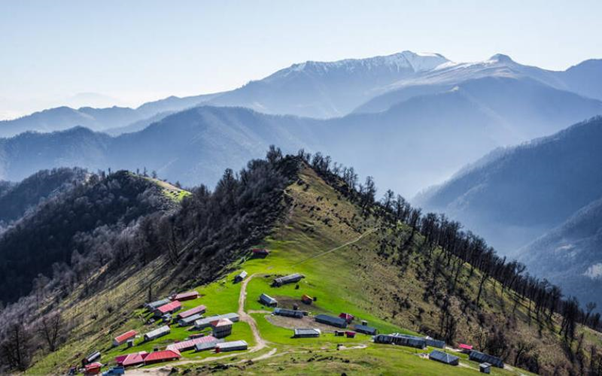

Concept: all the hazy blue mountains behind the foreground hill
[[0, 51, 602, 300]]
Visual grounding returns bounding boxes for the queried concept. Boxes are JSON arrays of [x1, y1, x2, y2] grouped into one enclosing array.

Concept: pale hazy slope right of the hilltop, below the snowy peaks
[[321, 77, 602, 196]]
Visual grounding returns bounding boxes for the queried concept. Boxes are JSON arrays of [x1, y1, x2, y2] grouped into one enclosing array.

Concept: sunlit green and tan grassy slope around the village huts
[[23, 165, 602, 375]]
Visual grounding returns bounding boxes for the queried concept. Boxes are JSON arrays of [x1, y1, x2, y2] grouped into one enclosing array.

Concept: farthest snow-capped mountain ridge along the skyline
[[0, 51, 602, 137]]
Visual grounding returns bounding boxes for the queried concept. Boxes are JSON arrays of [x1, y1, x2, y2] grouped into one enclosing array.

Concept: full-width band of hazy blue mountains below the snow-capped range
[[0, 81, 602, 196]]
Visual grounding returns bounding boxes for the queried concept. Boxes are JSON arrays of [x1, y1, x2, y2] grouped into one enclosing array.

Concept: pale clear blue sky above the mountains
[[0, 0, 602, 119]]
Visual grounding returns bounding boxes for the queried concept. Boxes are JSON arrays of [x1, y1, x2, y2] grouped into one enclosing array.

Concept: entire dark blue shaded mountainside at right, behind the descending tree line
[[415, 117, 602, 307]]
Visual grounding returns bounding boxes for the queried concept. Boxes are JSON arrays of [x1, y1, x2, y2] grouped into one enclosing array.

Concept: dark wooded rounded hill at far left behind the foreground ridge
[[0, 170, 172, 302]]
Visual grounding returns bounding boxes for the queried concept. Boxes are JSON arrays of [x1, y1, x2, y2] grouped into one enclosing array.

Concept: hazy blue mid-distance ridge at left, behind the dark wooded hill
[[0, 107, 318, 186]]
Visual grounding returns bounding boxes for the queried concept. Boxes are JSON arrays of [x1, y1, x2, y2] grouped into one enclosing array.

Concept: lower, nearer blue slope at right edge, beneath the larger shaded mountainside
[[517, 198, 602, 307]]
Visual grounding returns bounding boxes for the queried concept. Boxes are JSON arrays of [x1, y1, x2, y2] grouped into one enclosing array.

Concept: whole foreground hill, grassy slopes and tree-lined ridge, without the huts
[[0, 148, 602, 375]]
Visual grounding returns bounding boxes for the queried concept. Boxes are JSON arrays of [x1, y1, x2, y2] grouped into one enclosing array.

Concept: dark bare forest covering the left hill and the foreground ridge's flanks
[[0, 147, 602, 374]]
